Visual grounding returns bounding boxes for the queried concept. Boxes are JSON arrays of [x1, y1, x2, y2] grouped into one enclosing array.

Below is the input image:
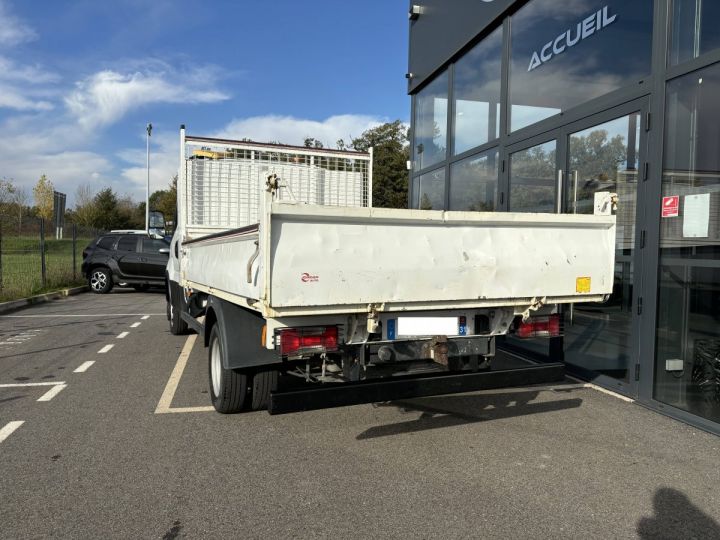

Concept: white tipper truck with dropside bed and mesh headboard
[[167, 126, 615, 413]]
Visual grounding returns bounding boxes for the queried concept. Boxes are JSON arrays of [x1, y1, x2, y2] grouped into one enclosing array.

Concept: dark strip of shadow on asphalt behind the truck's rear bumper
[[356, 391, 583, 440]]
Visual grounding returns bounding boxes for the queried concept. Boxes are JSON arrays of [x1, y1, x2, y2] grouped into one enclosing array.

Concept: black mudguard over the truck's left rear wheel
[[205, 296, 282, 369]]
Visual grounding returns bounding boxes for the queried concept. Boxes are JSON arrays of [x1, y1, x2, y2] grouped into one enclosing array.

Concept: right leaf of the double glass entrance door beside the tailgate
[[563, 100, 647, 395]]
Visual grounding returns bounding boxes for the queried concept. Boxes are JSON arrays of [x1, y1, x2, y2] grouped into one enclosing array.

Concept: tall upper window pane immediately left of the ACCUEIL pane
[[453, 28, 502, 154]]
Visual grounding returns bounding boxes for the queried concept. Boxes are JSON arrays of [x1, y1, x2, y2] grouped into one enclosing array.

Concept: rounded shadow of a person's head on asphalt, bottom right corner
[[637, 487, 720, 540]]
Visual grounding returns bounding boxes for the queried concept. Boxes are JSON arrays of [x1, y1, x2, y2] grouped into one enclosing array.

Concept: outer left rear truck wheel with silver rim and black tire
[[208, 324, 248, 414]]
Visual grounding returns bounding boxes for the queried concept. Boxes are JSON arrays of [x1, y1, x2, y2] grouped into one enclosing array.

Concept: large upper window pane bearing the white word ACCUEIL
[[510, 0, 653, 131]]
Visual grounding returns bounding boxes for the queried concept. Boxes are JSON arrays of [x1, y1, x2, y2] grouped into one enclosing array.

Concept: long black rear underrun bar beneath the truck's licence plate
[[268, 363, 565, 414]]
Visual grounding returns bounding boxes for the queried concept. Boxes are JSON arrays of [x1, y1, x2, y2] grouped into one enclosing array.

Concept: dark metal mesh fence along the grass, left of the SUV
[[0, 218, 98, 301]]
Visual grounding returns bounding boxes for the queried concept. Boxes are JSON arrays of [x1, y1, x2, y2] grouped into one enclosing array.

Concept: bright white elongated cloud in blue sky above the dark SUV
[[65, 67, 229, 128]]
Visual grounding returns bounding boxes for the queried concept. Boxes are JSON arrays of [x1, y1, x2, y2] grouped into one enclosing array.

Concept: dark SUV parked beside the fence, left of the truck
[[82, 233, 170, 294]]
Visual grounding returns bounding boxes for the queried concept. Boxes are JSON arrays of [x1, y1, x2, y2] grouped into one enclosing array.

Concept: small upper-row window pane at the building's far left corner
[[413, 72, 448, 171]]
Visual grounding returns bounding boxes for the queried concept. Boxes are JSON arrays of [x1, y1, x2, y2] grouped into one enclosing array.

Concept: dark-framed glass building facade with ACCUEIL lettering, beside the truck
[[410, 0, 720, 432]]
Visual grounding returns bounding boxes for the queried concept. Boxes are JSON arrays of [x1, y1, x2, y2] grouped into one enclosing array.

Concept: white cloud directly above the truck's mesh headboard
[[214, 114, 387, 148]]
